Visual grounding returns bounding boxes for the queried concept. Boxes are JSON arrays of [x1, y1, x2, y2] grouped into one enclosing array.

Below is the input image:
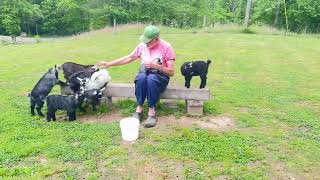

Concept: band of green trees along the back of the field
[[0, 0, 320, 36]]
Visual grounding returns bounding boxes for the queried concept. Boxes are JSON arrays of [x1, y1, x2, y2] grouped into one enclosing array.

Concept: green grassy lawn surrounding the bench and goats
[[0, 26, 320, 179]]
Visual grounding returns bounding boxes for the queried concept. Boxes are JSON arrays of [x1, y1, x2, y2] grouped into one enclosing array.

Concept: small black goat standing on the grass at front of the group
[[47, 94, 83, 122]]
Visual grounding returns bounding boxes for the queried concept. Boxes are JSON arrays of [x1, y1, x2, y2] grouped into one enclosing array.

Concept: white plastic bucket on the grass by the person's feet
[[120, 117, 140, 141]]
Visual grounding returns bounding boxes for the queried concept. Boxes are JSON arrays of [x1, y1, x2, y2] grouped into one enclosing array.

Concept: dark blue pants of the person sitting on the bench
[[134, 73, 170, 108]]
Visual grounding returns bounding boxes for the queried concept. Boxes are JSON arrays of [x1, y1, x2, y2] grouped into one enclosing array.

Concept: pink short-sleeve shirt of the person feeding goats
[[131, 39, 176, 66]]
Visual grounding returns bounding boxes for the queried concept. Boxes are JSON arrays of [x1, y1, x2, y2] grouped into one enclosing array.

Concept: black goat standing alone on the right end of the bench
[[181, 60, 211, 89]]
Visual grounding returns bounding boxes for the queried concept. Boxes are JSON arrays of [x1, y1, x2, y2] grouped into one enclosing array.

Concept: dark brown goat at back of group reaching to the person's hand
[[59, 62, 94, 81]]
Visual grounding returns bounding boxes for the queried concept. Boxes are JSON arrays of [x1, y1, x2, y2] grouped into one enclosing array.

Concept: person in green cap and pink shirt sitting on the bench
[[98, 25, 175, 128]]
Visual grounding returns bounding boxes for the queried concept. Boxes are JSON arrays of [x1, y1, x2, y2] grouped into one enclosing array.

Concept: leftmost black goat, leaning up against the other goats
[[28, 66, 60, 116]]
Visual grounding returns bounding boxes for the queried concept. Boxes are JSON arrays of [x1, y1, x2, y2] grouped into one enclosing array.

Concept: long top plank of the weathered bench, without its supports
[[104, 83, 211, 101]]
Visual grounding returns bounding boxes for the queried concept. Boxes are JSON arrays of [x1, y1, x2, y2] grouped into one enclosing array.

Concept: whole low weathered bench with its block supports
[[103, 83, 211, 115]]
